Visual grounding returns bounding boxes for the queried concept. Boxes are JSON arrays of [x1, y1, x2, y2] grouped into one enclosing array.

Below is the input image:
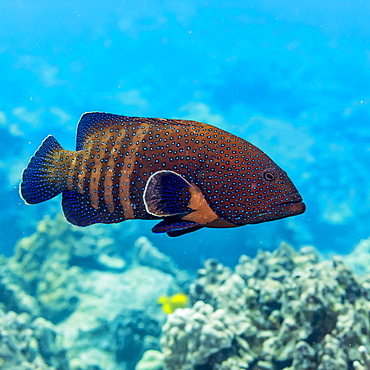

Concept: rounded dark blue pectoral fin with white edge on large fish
[[143, 170, 192, 217]]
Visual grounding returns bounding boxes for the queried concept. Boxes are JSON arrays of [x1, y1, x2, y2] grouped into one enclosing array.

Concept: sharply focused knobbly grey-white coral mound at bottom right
[[161, 243, 370, 370]]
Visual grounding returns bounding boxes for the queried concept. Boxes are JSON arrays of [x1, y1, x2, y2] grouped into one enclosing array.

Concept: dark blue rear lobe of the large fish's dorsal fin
[[76, 112, 120, 150]]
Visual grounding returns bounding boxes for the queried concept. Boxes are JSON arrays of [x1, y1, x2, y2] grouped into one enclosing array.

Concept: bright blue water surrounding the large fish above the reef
[[0, 0, 370, 267]]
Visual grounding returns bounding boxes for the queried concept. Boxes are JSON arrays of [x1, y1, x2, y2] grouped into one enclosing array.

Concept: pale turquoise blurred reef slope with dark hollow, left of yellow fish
[[58, 266, 178, 370]]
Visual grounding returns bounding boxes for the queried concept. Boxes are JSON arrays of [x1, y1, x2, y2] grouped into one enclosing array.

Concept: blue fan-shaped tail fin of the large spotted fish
[[19, 135, 65, 204]]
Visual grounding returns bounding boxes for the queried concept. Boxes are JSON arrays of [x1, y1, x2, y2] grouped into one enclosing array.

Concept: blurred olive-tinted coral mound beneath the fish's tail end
[[8, 215, 125, 323]]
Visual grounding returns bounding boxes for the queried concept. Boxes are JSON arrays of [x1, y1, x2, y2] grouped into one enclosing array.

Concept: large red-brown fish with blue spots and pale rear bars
[[20, 112, 306, 237]]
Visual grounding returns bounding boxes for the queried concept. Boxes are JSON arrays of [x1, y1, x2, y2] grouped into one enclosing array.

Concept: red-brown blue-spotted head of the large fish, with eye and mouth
[[205, 143, 306, 226]]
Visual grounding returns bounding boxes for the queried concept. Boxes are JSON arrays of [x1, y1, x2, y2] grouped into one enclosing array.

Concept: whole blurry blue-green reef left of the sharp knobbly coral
[[0, 216, 188, 370]]
